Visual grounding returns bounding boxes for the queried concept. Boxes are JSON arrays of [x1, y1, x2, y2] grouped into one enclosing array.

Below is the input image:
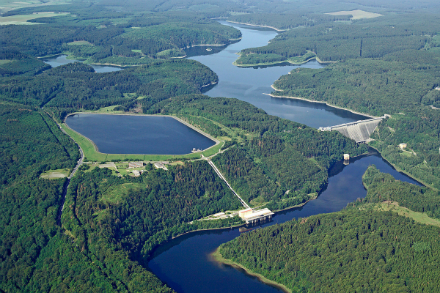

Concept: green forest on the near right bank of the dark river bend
[[219, 166, 440, 292]]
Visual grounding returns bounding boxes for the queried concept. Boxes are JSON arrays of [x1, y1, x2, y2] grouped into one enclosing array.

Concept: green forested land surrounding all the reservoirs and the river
[[0, 0, 440, 292]]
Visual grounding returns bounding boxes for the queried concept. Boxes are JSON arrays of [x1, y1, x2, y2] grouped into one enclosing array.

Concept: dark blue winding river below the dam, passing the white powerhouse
[[148, 154, 419, 293]]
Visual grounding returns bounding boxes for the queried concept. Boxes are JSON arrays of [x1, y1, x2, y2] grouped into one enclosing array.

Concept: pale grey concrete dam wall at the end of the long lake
[[319, 115, 388, 143]]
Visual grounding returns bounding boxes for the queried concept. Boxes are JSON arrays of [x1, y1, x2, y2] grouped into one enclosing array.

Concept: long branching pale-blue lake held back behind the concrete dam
[[187, 21, 367, 128]]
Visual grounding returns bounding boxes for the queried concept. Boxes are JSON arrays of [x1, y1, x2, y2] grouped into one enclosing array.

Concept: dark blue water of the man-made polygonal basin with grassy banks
[[66, 113, 215, 155]]
